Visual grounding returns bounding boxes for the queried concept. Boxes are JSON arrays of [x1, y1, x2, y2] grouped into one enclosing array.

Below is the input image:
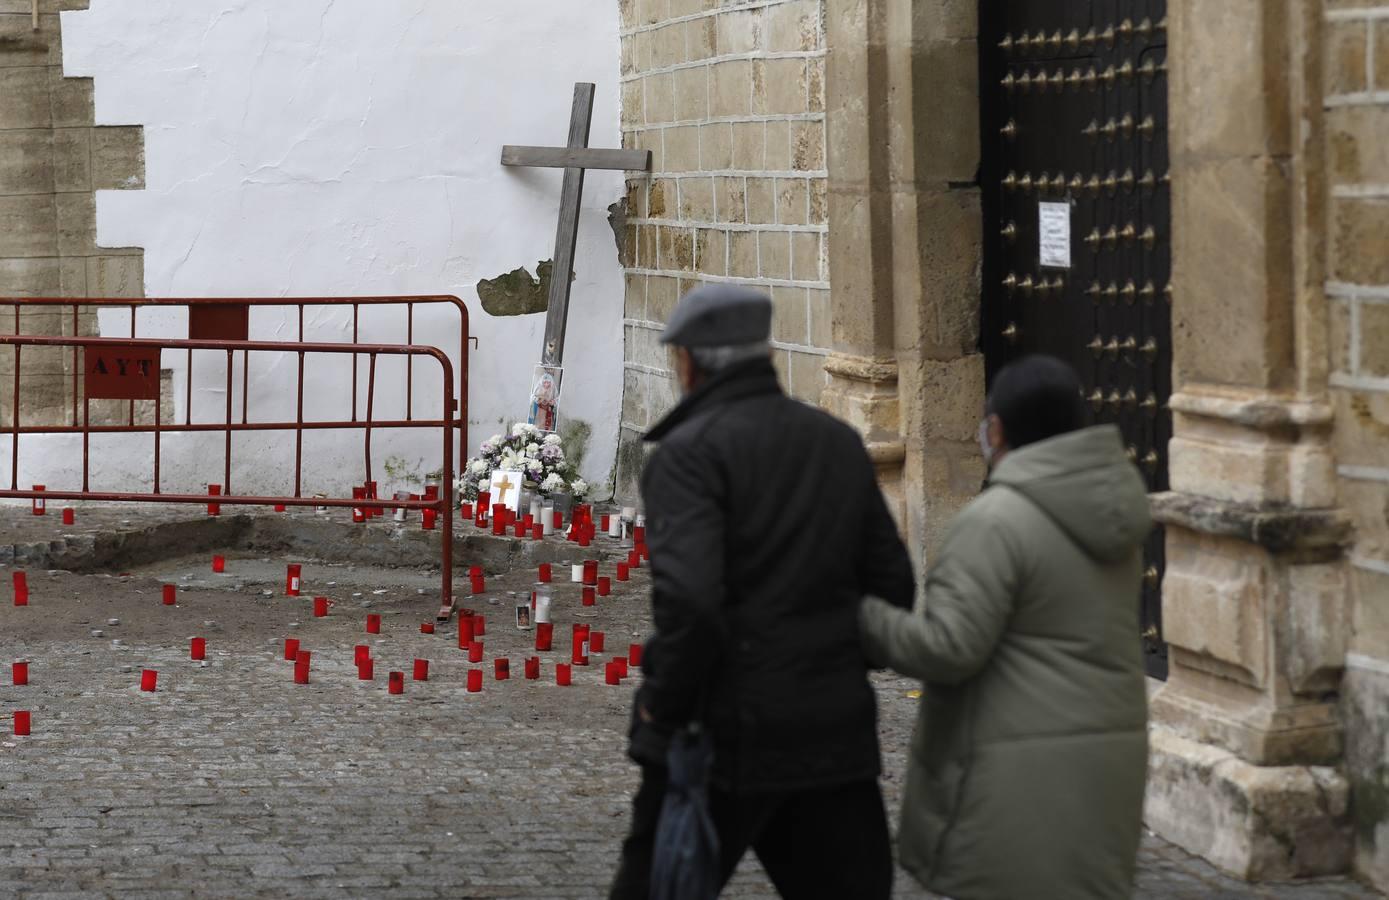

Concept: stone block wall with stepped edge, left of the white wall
[[0, 0, 144, 424]]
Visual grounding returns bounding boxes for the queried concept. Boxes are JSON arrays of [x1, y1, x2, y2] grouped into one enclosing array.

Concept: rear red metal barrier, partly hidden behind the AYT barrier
[[0, 294, 471, 458]]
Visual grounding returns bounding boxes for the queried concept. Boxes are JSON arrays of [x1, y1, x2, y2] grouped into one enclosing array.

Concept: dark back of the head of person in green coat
[[986, 356, 1085, 449]]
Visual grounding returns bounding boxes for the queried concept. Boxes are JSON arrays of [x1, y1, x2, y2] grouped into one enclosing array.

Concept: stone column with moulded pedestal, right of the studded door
[[1147, 0, 1350, 879]]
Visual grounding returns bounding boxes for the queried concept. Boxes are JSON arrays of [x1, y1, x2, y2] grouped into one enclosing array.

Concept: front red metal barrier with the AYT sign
[[0, 335, 465, 618]]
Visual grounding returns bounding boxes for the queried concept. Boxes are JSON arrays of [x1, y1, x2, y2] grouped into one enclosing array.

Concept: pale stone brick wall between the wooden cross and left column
[[617, 0, 831, 496]]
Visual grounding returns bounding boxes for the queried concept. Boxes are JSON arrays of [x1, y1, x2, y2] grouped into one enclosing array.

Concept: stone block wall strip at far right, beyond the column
[[1325, 0, 1389, 888]]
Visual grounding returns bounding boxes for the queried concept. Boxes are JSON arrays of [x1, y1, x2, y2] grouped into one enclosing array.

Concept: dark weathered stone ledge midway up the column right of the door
[[1150, 492, 1353, 561]]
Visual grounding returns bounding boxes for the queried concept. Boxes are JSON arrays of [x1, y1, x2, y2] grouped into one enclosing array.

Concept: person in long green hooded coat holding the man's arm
[[860, 357, 1151, 900]]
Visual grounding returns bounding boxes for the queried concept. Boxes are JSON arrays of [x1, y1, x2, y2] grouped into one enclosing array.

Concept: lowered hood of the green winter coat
[[989, 425, 1153, 563]]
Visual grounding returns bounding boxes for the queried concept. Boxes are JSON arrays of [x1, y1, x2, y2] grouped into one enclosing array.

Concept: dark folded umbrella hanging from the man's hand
[[651, 725, 720, 900]]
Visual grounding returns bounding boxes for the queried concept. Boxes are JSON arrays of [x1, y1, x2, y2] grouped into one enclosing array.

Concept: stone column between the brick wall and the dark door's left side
[[821, 0, 983, 563]]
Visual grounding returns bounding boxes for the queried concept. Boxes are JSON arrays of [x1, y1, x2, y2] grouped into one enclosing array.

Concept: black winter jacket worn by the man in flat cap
[[631, 360, 914, 792]]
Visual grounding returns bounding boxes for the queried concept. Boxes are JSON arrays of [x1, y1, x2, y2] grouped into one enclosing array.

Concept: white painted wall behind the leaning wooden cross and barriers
[[39, 0, 624, 493]]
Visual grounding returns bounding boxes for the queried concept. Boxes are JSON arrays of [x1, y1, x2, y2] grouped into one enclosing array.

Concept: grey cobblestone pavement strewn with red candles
[[0, 515, 1378, 900]]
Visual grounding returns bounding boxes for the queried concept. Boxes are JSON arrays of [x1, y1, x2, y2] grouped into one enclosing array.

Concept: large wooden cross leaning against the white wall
[[501, 82, 651, 365]]
